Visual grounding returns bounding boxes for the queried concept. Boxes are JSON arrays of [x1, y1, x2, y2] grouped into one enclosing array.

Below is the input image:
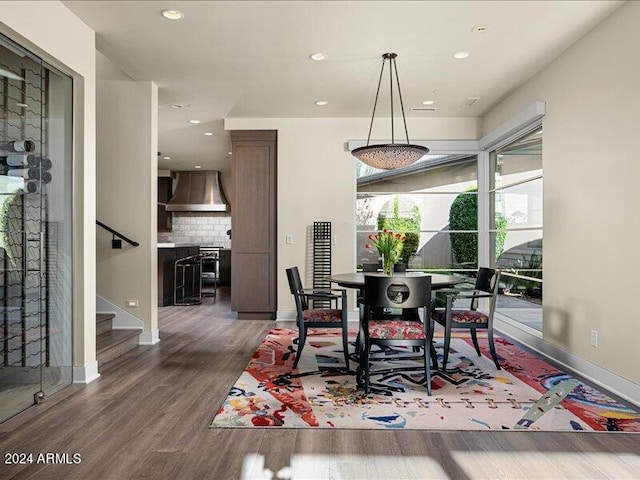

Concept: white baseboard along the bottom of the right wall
[[494, 314, 640, 407]]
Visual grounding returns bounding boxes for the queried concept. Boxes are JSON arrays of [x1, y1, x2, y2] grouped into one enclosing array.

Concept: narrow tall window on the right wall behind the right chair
[[489, 128, 543, 331]]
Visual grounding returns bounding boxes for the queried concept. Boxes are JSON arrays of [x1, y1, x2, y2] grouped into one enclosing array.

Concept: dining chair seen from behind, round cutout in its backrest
[[358, 275, 432, 395]]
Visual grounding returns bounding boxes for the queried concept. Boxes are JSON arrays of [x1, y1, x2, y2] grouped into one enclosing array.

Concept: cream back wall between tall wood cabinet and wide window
[[225, 118, 480, 311]]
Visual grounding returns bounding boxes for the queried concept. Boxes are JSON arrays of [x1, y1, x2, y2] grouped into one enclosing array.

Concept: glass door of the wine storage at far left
[[0, 36, 72, 421]]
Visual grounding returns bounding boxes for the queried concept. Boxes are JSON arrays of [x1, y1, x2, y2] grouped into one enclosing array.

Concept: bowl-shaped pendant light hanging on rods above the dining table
[[351, 53, 429, 170]]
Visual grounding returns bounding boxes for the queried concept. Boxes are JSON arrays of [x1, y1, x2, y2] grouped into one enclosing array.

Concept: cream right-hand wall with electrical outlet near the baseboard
[[483, 2, 640, 384]]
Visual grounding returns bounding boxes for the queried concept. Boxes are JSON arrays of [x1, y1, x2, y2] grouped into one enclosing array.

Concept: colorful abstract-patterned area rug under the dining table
[[211, 329, 640, 432]]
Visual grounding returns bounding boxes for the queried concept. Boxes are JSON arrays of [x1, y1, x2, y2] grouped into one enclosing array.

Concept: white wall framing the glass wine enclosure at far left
[[0, 1, 97, 381]]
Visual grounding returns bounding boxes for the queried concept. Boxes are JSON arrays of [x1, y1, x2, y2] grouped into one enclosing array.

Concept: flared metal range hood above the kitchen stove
[[167, 171, 229, 212]]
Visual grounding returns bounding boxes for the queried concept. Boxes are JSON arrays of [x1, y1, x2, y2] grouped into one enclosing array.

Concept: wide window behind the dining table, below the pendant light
[[356, 155, 478, 272]]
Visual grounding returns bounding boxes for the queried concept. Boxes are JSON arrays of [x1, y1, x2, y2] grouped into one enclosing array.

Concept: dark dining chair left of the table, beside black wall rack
[[287, 267, 350, 371]]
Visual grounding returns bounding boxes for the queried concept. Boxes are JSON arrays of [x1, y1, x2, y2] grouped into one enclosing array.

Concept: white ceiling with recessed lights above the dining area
[[63, 0, 624, 170]]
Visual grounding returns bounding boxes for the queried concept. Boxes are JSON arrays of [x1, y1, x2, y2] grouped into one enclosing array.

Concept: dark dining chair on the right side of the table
[[431, 267, 500, 370]]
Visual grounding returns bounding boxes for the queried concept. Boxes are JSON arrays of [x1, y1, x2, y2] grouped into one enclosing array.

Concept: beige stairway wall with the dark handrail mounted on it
[[96, 63, 158, 339]]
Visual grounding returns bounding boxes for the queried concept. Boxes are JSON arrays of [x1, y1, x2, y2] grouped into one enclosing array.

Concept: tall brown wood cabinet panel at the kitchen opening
[[231, 130, 277, 319]]
